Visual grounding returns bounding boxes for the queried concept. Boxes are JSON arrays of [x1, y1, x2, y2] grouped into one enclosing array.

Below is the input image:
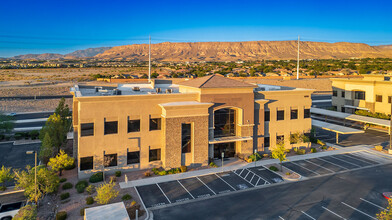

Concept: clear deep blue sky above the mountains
[[0, 0, 392, 57]]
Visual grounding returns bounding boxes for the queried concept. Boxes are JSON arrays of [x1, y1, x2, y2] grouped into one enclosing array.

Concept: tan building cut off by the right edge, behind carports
[[331, 75, 392, 114]]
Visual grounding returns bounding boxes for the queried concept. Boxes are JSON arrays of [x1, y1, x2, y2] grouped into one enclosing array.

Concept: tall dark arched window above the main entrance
[[214, 108, 236, 137]]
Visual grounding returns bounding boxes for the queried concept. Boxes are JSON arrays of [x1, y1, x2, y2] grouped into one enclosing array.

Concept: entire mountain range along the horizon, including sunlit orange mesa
[[9, 41, 392, 61]]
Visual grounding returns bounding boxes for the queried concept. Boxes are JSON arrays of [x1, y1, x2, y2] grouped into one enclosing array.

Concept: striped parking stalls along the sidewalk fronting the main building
[[136, 151, 388, 208]]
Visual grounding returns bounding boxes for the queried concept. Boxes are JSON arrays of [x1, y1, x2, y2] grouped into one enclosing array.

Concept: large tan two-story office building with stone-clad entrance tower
[[71, 75, 313, 178]]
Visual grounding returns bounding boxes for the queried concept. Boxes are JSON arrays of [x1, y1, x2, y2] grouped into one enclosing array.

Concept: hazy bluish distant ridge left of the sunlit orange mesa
[[12, 47, 111, 60]]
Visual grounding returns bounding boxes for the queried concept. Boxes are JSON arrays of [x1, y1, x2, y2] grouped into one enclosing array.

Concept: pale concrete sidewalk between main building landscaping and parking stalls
[[119, 145, 392, 188]]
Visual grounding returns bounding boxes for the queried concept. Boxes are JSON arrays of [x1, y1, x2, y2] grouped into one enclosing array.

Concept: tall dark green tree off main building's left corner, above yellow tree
[[39, 113, 67, 152]]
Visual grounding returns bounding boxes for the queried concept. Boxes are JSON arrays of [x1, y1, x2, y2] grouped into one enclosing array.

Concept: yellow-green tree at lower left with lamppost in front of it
[[15, 166, 60, 203]]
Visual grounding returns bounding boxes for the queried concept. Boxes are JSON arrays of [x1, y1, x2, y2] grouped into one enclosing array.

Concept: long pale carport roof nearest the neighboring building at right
[[310, 108, 391, 128]]
